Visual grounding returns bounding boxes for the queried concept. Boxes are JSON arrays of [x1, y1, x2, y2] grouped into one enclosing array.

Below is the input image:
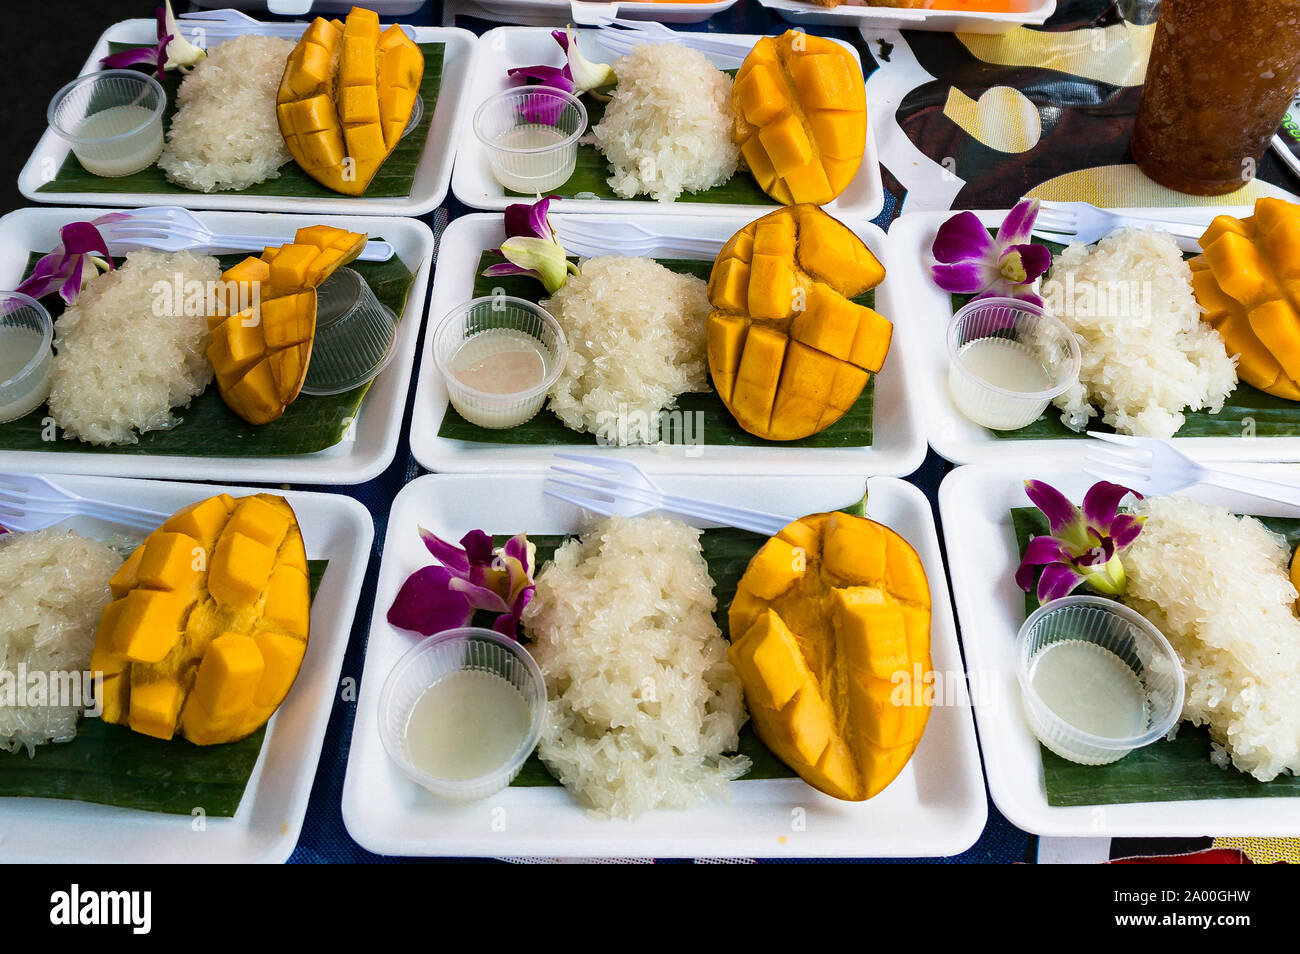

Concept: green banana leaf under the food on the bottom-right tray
[[1011, 507, 1300, 807]]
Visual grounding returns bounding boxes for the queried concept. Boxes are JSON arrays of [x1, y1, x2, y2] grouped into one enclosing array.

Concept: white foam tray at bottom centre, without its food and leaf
[[343, 474, 988, 858]]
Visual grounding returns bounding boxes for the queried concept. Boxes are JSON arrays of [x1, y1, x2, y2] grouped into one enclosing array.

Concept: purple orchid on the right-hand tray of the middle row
[[931, 199, 1052, 305]]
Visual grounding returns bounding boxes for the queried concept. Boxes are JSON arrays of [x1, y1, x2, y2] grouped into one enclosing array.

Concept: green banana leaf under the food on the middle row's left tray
[[0, 246, 415, 458]]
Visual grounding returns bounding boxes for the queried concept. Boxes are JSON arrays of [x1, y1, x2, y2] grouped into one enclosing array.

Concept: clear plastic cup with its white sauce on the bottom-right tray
[[1017, 595, 1184, 766]]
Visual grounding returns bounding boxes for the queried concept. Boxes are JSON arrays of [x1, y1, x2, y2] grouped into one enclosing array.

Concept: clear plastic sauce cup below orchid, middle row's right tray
[[948, 298, 1082, 430]]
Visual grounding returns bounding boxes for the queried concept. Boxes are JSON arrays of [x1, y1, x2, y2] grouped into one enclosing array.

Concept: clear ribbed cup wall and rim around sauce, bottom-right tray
[[1017, 597, 1186, 766]]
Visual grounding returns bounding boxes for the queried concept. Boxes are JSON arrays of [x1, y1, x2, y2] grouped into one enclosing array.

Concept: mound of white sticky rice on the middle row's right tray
[[1043, 229, 1236, 438]]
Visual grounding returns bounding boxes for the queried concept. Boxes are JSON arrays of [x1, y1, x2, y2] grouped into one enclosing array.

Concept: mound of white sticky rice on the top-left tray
[[159, 36, 294, 192]]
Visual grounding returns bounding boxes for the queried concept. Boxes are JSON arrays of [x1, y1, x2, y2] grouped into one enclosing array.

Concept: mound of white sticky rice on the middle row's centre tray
[[542, 255, 709, 445]]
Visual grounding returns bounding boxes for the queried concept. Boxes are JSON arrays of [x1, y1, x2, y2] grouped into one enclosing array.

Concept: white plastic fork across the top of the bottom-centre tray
[[546, 454, 792, 537]]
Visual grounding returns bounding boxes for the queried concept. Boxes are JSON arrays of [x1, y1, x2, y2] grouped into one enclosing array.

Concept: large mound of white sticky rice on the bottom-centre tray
[[524, 517, 750, 818]]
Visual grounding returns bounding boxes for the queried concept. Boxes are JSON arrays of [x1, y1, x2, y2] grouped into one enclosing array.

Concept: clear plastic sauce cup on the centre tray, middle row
[[433, 295, 568, 429]]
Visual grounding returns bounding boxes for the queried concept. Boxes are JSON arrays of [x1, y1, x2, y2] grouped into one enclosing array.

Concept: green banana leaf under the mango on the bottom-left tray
[[0, 560, 329, 818]]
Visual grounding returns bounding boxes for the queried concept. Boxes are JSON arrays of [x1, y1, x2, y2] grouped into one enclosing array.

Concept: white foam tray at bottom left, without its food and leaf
[[0, 477, 374, 864]]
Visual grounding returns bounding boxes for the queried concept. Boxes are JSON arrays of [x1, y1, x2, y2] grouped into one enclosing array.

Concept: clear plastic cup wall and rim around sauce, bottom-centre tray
[[378, 626, 546, 802]]
